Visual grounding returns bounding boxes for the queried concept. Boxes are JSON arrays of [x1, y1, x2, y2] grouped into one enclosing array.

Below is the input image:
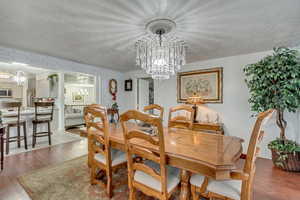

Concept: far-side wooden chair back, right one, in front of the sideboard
[[168, 105, 195, 129]]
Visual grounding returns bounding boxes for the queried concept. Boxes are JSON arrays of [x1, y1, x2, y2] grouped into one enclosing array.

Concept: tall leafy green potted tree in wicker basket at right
[[244, 47, 300, 171]]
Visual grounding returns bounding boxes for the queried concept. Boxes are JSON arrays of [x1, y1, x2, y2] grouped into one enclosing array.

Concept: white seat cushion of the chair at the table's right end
[[190, 174, 242, 200]]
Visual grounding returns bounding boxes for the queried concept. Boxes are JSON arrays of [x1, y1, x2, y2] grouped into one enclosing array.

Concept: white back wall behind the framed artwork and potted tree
[[125, 52, 300, 158]]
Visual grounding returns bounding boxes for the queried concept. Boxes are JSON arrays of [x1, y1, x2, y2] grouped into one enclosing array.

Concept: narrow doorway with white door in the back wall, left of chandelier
[[137, 78, 154, 111]]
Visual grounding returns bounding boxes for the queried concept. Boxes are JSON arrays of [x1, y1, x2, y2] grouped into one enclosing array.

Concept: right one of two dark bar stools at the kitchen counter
[[32, 102, 54, 148]]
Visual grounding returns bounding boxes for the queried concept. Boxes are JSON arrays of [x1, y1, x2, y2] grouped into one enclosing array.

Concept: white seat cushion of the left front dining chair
[[94, 149, 127, 166]]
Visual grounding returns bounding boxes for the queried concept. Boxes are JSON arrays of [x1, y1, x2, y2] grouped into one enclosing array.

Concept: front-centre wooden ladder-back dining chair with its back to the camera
[[120, 110, 180, 200]]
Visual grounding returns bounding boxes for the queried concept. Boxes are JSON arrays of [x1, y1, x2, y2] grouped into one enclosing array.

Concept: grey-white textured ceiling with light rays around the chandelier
[[0, 0, 300, 71]]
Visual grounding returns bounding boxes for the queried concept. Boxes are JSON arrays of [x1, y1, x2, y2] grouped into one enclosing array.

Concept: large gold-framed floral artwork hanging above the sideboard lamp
[[177, 67, 223, 103]]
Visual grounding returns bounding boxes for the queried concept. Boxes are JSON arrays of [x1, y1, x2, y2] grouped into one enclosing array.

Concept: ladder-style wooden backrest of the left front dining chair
[[84, 105, 111, 166]]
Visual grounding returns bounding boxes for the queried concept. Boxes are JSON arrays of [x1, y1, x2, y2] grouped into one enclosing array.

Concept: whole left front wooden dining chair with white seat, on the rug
[[85, 106, 127, 198]]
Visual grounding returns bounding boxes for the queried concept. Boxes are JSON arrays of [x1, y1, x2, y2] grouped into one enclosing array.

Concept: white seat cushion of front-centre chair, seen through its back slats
[[134, 161, 180, 192]]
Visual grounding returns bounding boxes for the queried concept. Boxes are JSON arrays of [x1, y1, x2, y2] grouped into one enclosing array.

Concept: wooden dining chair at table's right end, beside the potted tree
[[190, 110, 274, 200]]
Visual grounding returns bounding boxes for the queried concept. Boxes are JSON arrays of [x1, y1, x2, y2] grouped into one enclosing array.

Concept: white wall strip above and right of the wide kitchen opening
[[0, 47, 125, 110]]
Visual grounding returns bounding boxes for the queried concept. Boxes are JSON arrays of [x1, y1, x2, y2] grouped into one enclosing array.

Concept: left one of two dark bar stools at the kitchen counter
[[1, 102, 27, 154]]
